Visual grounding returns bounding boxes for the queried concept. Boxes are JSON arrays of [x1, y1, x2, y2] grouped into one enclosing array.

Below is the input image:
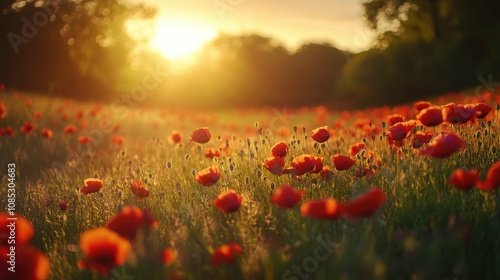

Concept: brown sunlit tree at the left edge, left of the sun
[[0, 0, 154, 99]]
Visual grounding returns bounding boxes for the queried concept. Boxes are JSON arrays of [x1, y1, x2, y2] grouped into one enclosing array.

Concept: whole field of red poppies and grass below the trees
[[0, 92, 500, 280]]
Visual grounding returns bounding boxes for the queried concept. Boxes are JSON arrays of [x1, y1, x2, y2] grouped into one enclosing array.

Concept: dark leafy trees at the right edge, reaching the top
[[339, 0, 500, 106]]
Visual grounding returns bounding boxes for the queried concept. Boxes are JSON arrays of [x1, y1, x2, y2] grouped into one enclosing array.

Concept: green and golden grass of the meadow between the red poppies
[[0, 93, 500, 279]]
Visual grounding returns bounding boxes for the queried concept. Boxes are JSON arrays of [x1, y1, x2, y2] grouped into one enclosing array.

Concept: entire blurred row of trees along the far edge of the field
[[0, 0, 500, 108]]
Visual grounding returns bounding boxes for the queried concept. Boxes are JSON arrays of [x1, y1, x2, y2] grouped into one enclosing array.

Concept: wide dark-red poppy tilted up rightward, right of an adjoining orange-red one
[[340, 188, 385, 219]]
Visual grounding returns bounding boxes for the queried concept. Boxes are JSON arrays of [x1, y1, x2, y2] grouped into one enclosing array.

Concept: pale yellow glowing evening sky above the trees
[[129, 0, 373, 57]]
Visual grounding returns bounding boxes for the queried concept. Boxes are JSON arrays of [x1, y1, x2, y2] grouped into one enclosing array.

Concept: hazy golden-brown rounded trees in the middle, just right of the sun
[[159, 34, 346, 107]]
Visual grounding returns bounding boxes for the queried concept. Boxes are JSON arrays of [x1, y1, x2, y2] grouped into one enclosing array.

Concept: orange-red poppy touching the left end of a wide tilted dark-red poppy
[[300, 198, 339, 220]]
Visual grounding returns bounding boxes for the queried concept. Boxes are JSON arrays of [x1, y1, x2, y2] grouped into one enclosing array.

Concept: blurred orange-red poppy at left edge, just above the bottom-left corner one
[[0, 213, 35, 247]]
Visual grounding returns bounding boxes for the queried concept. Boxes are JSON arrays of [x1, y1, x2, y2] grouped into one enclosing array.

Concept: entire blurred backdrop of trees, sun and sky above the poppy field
[[0, 0, 500, 109]]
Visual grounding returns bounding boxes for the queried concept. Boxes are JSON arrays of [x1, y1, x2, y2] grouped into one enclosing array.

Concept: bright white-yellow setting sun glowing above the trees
[[150, 18, 217, 60]]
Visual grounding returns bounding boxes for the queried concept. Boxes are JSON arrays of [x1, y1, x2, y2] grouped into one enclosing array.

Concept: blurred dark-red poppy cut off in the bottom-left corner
[[0, 243, 50, 280]]
